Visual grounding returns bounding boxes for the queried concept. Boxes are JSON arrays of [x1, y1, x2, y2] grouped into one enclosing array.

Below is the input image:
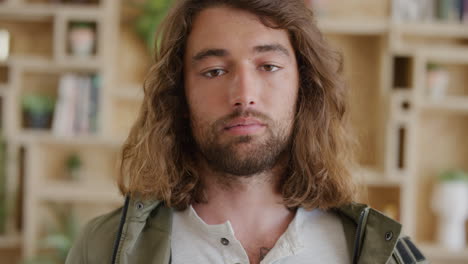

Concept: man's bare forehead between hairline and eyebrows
[[186, 7, 292, 56]]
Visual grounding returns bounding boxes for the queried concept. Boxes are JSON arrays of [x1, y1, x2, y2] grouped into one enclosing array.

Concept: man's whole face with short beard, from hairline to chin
[[184, 7, 299, 176]]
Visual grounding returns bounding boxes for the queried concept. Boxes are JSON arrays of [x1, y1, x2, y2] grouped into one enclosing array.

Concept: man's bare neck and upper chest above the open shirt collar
[[193, 159, 295, 252]]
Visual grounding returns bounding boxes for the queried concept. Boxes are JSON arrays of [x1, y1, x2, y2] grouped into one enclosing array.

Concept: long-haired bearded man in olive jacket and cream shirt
[[67, 0, 425, 264]]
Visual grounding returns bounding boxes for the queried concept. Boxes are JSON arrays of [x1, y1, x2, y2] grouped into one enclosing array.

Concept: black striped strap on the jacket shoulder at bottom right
[[394, 236, 429, 264]]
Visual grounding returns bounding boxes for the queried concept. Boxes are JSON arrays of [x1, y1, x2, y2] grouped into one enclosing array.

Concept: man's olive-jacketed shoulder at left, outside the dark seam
[[66, 208, 122, 264]]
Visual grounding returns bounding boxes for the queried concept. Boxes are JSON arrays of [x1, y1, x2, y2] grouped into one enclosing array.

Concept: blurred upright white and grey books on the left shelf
[[52, 73, 100, 136]]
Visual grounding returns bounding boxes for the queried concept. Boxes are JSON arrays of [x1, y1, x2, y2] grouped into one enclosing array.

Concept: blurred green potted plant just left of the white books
[[21, 94, 55, 129]]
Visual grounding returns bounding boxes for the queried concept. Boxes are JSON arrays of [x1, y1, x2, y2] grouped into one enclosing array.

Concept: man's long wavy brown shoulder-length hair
[[118, 0, 356, 209]]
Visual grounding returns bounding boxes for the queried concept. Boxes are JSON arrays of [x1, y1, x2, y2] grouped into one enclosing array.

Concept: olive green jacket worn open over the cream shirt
[[66, 198, 428, 264]]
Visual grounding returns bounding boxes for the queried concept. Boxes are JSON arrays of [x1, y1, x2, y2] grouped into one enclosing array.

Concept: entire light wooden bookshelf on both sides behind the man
[[0, 0, 468, 264]]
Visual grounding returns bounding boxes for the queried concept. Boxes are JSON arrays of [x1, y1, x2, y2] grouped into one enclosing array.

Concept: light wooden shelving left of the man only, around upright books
[[0, 0, 123, 263]]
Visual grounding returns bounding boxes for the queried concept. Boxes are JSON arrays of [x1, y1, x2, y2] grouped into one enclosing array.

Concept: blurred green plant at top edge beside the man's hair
[[128, 0, 173, 52]]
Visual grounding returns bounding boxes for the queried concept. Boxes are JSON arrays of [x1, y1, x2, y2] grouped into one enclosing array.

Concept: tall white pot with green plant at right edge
[[432, 170, 468, 251]]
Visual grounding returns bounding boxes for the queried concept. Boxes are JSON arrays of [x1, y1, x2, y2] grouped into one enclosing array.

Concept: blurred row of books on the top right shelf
[[393, 0, 468, 23]]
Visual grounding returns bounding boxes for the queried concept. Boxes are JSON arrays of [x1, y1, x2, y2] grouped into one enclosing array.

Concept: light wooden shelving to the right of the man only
[[317, 0, 468, 264]]
